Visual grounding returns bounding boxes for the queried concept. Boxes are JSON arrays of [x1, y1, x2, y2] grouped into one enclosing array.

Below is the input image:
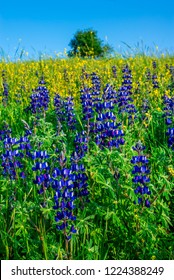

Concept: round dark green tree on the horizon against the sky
[[68, 29, 113, 57]]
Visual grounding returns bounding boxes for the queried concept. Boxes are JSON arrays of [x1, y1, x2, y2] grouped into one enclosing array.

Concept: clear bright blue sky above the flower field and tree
[[0, 0, 174, 57]]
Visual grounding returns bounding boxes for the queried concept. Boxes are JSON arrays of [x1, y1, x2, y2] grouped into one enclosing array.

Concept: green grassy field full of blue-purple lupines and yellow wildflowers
[[0, 55, 174, 260]]
